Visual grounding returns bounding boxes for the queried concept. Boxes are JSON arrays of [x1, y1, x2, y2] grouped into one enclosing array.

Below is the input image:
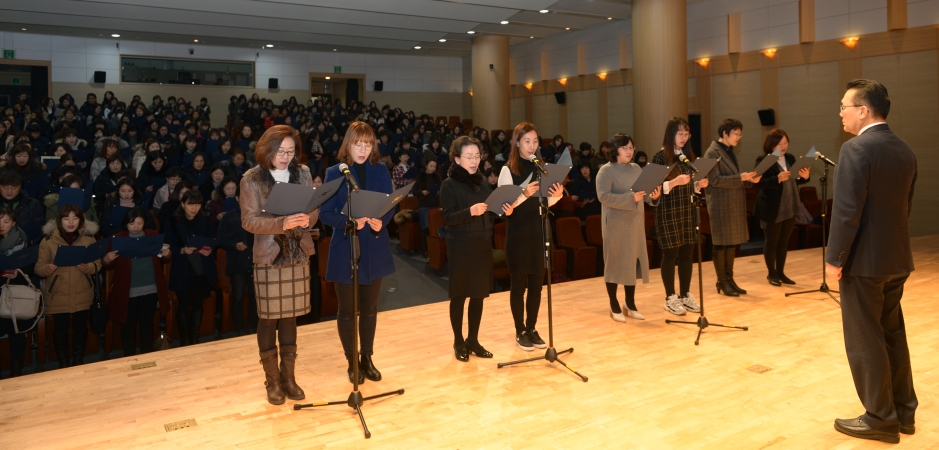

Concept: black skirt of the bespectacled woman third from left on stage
[[447, 239, 494, 298]]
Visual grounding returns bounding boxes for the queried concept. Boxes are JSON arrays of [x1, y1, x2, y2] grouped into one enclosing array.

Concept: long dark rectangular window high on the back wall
[[121, 56, 254, 87]]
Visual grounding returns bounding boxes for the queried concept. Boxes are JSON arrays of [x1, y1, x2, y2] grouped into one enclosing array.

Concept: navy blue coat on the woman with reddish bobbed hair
[[320, 162, 395, 284]]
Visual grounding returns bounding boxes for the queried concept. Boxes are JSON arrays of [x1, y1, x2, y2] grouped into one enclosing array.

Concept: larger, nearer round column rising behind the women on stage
[[632, 0, 688, 152]]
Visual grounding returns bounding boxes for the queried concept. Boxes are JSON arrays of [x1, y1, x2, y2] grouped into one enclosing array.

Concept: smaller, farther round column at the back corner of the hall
[[472, 35, 511, 130]]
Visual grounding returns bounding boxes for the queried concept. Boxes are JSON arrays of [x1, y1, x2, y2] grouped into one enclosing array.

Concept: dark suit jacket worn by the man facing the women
[[825, 124, 917, 277]]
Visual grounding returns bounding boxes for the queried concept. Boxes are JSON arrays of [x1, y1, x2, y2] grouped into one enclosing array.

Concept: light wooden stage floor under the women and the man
[[0, 236, 939, 449]]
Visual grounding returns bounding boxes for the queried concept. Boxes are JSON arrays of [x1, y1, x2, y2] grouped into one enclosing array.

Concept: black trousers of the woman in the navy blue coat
[[334, 278, 382, 359]]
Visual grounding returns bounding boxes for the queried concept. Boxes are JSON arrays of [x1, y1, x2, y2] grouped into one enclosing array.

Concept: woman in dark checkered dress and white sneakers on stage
[[652, 117, 708, 316]]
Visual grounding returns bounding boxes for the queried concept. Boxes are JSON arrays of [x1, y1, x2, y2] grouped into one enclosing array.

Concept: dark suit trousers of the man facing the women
[[840, 274, 919, 433]]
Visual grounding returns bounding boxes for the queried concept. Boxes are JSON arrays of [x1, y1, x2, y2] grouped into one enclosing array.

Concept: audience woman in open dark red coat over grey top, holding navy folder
[[101, 207, 172, 356]]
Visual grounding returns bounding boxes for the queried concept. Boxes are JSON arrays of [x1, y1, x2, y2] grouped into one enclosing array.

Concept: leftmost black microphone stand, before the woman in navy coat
[[293, 181, 404, 439]]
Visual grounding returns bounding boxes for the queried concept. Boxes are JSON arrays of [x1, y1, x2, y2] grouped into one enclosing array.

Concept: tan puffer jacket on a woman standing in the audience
[[35, 220, 101, 314]]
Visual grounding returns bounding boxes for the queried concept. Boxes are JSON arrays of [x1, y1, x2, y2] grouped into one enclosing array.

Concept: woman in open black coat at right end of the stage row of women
[[753, 128, 809, 286]]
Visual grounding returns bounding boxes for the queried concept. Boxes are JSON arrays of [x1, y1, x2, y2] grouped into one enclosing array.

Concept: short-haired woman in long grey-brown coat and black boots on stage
[[704, 119, 761, 297]]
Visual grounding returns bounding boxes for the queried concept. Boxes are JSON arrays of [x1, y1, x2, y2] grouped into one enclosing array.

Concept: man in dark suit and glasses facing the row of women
[[825, 79, 918, 443]]
